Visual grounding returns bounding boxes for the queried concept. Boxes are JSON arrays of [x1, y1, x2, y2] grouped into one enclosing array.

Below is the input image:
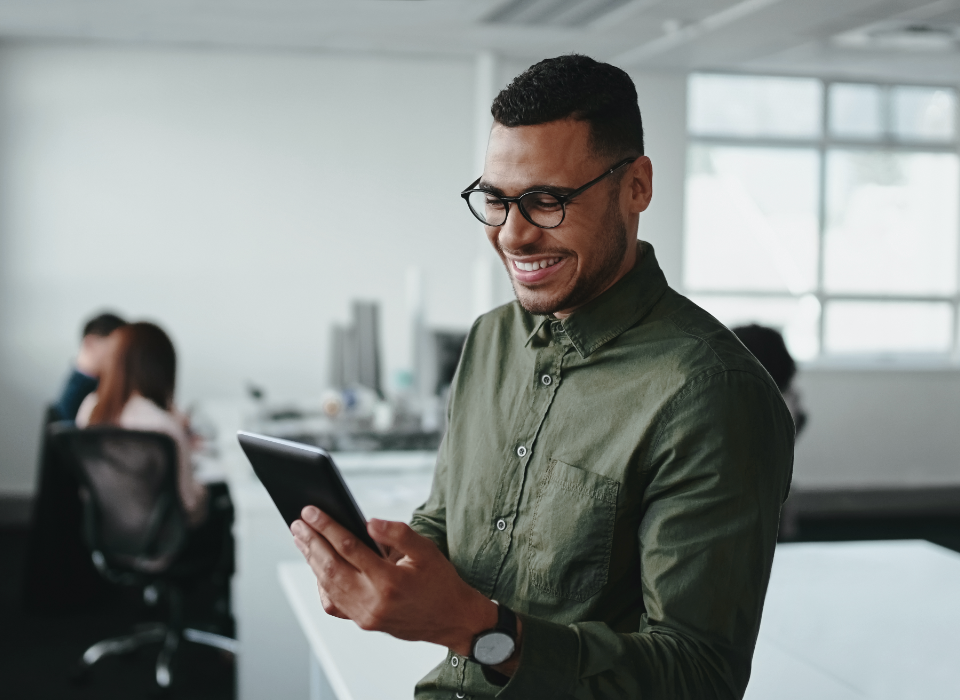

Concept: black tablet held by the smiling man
[[237, 430, 382, 556]]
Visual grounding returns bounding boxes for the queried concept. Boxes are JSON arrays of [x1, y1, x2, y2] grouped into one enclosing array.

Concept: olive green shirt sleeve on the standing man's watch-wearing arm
[[497, 370, 794, 700]]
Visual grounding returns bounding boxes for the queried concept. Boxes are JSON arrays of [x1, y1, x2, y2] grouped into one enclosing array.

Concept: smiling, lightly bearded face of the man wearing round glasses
[[478, 120, 649, 317]]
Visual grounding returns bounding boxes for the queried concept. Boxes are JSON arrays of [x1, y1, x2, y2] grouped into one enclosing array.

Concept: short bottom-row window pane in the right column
[[823, 301, 953, 354]]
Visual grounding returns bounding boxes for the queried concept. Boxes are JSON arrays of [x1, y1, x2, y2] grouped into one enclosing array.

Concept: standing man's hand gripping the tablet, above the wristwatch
[[290, 506, 497, 656]]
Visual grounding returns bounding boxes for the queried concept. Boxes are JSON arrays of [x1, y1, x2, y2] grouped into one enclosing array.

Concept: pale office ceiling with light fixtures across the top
[[0, 0, 960, 84]]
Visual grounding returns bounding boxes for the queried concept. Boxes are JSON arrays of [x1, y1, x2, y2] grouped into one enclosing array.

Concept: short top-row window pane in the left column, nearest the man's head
[[687, 74, 823, 138]]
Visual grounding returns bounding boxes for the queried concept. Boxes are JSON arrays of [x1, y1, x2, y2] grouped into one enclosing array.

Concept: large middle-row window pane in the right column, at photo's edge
[[824, 150, 960, 294]]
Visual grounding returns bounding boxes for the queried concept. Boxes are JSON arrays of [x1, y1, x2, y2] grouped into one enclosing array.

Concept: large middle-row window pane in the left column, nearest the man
[[684, 144, 819, 295]]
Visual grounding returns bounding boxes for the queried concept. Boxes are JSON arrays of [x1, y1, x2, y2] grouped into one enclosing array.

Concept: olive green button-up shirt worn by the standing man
[[411, 243, 794, 700]]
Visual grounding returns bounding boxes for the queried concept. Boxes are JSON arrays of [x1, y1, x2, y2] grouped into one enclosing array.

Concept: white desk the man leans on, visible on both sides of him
[[279, 542, 960, 700]]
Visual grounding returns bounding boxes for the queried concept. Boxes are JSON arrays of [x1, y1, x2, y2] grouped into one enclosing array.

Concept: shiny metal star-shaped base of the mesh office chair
[[74, 623, 240, 689]]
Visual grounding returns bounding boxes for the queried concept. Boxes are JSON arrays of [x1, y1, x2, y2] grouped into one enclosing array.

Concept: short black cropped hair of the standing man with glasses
[[490, 54, 643, 158]]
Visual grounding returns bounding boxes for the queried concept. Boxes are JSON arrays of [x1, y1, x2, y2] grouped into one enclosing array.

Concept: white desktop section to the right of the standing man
[[746, 541, 960, 700]]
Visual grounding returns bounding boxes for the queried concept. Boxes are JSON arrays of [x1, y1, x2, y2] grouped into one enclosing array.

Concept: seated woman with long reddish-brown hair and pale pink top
[[77, 322, 208, 528]]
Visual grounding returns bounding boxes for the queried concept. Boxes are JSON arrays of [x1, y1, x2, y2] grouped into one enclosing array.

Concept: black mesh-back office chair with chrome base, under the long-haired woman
[[49, 424, 238, 689]]
